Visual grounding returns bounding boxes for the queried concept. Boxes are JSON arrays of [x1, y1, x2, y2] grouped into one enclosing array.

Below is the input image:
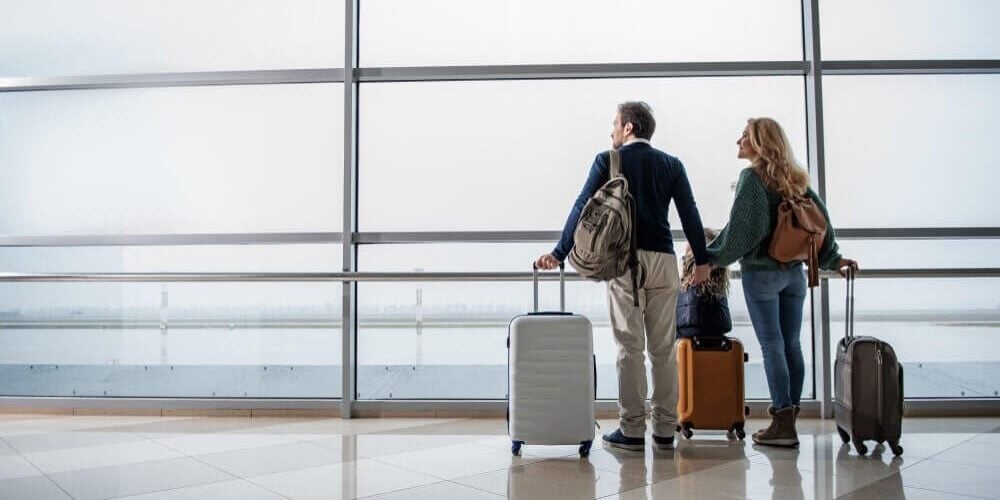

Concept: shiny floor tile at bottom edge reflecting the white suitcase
[[454, 458, 646, 500]]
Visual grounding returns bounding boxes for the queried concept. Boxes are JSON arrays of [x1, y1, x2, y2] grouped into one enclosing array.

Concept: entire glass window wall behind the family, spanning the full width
[[0, 0, 1000, 404]]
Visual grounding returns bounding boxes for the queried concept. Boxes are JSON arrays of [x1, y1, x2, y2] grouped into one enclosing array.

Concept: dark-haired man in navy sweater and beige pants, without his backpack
[[536, 102, 711, 450]]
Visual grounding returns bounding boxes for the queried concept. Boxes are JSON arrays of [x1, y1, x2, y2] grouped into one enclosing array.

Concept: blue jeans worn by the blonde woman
[[742, 264, 806, 410]]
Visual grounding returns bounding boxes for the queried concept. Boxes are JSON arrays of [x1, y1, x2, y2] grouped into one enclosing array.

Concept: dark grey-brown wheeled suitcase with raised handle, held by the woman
[[833, 270, 903, 456]]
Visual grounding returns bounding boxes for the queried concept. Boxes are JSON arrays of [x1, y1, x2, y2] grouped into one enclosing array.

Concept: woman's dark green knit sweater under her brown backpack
[[708, 167, 840, 271]]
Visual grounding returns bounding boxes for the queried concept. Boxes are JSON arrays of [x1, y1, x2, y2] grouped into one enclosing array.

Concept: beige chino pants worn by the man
[[608, 250, 680, 438]]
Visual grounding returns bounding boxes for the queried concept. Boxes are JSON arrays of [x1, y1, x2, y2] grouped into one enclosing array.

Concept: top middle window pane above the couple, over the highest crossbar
[[361, 0, 802, 67]]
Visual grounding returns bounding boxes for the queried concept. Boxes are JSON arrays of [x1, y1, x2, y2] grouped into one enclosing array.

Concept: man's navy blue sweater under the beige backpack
[[552, 142, 708, 264]]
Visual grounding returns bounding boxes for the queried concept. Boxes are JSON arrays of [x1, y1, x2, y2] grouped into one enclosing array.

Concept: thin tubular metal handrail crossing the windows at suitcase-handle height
[[0, 263, 1000, 283]]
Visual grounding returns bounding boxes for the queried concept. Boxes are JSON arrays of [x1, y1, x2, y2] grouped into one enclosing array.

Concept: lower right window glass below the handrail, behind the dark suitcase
[[830, 278, 1000, 398]]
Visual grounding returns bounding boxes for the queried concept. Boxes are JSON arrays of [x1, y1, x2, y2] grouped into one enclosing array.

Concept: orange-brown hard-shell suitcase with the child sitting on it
[[677, 336, 750, 439]]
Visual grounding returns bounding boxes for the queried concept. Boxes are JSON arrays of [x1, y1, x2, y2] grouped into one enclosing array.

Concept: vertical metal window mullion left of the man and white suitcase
[[340, 0, 358, 418]]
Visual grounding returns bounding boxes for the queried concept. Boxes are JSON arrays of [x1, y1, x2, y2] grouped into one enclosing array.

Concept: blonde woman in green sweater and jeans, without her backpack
[[708, 118, 858, 446]]
